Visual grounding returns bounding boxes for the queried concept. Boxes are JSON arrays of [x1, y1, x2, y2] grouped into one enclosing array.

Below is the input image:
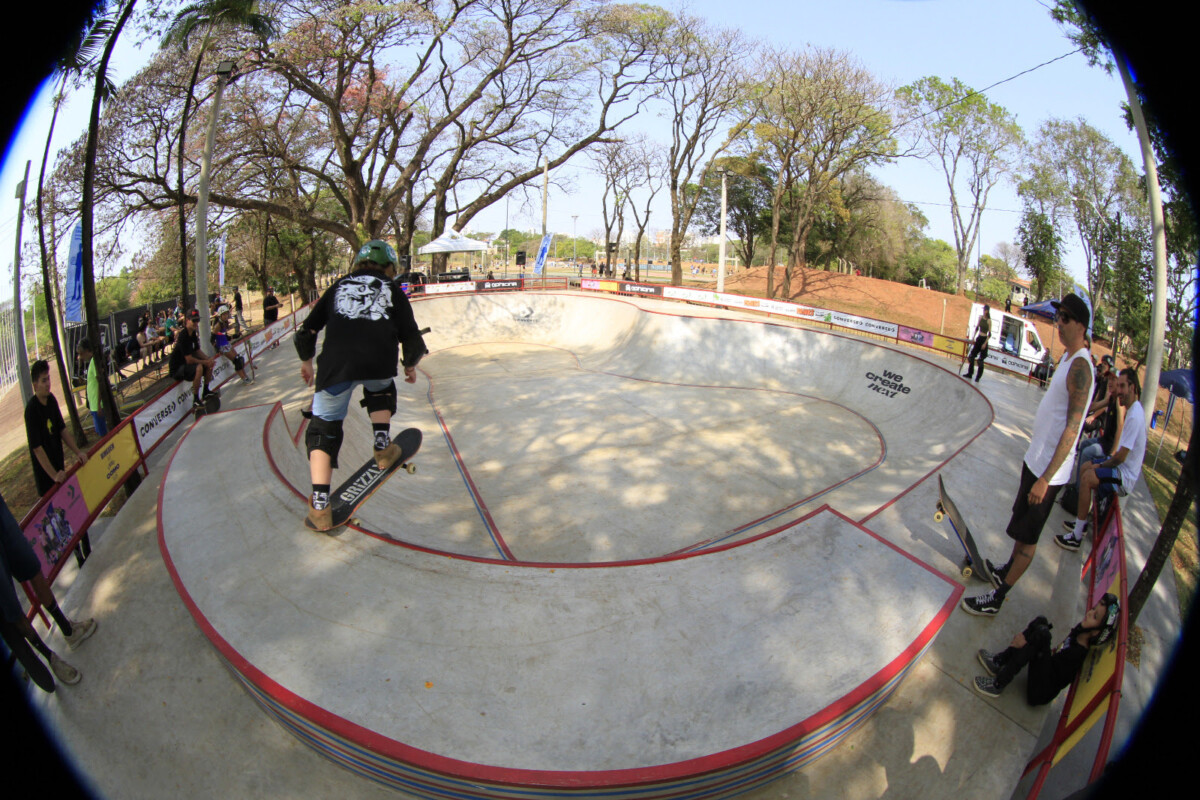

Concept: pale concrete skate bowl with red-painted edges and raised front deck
[[158, 294, 991, 799]]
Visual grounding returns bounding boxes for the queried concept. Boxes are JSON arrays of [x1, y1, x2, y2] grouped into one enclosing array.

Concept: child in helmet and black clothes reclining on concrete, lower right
[[974, 594, 1121, 705]]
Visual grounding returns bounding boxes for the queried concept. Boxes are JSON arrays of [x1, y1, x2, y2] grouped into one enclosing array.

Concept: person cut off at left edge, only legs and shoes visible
[[0, 489, 96, 691]]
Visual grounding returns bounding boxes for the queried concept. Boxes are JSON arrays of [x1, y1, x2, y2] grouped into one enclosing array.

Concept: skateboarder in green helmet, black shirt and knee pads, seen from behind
[[295, 239, 427, 530]]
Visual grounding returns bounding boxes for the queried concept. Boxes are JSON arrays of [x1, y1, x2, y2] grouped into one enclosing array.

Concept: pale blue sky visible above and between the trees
[[0, 0, 1141, 297]]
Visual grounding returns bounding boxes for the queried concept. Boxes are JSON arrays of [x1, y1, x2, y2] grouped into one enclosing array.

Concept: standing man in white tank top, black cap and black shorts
[[962, 294, 1096, 616]]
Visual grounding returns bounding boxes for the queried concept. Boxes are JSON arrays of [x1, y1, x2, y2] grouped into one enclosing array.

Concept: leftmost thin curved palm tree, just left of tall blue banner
[[37, 5, 114, 444]]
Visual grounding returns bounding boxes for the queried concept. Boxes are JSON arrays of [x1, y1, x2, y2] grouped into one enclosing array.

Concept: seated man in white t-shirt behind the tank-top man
[[1055, 367, 1146, 551]]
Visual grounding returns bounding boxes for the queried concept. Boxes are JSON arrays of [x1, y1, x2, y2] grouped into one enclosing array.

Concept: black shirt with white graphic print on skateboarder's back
[[301, 267, 420, 391]]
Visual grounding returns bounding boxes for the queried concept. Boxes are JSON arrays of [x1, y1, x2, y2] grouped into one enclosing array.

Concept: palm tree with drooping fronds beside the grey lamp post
[[162, 0, 275, 306]]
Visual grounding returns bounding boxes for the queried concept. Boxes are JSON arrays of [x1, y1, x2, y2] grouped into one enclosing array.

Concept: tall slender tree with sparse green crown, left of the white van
[[896, 77, 1024, 291]]
